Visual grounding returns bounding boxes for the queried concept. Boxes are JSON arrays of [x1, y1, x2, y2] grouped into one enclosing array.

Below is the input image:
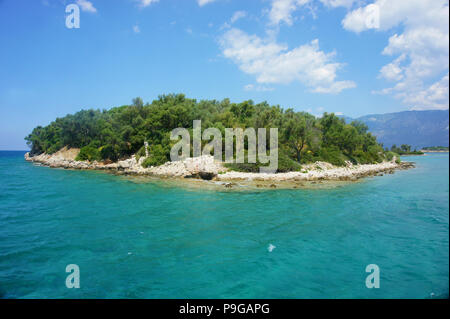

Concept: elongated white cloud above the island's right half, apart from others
[[220, 29, 356, 93]]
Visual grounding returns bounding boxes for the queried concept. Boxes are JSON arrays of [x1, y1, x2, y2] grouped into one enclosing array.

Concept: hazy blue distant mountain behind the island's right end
[[343, 110, 449, 148]]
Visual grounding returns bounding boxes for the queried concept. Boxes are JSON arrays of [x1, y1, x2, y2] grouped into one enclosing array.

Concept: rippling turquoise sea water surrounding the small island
[[0, 152, 449, 298]]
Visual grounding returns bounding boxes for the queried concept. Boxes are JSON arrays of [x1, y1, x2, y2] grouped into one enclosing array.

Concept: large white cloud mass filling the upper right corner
[[342, 0, 449, 109]]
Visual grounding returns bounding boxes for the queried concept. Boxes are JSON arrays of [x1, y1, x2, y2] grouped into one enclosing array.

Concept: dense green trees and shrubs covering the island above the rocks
[[25, 94, 388, 171]]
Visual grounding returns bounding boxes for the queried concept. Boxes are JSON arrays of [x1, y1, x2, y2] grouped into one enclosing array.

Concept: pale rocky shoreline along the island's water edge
[[25, 148, 414, 188]]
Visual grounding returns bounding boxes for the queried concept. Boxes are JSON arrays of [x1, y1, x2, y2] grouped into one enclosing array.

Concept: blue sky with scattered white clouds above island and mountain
[[0, 0, 449, 150]]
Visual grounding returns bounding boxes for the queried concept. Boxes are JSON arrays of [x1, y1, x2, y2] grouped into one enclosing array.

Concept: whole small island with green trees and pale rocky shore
[[25, 94, 410, 186]]
